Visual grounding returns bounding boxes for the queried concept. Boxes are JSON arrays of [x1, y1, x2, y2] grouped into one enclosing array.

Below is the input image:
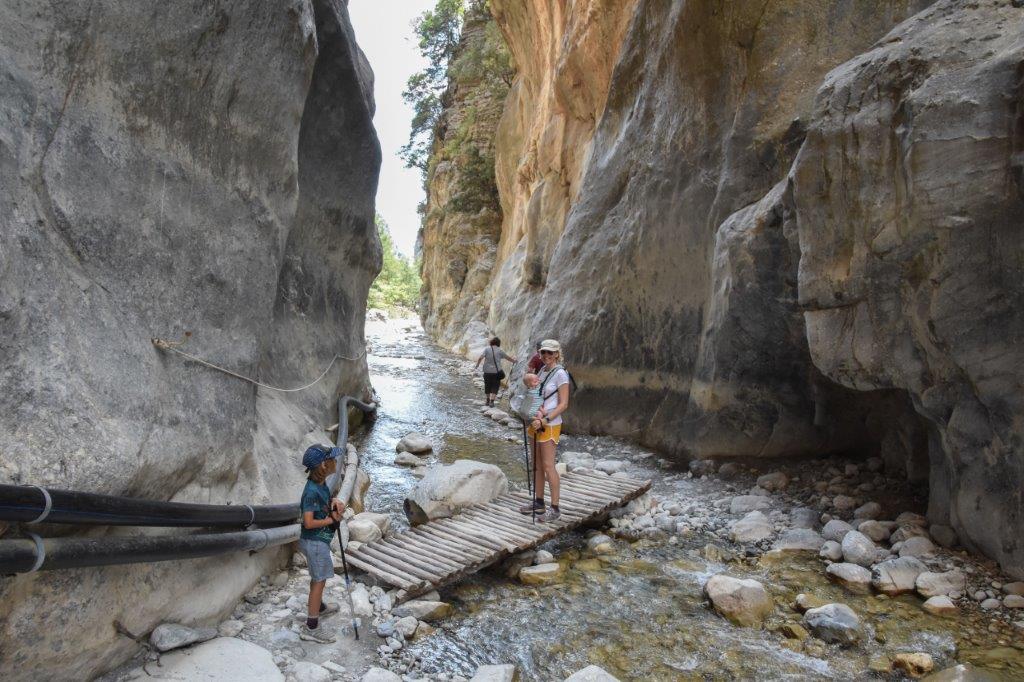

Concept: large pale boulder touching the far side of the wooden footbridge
[[404, 460, 508, 525]]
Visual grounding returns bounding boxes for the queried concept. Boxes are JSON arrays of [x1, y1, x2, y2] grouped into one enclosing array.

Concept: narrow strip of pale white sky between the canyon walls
[[348, 0, 435, 257]]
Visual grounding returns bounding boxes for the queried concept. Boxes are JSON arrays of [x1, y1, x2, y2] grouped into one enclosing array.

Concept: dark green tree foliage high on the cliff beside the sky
[[399, 0, 464, 173]]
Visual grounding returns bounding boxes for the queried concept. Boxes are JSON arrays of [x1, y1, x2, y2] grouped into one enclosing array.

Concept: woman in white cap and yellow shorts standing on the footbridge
[[519, 339, 569, 522]]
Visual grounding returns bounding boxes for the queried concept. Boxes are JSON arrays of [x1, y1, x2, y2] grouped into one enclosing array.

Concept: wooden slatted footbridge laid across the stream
[[345, 472, 650, 597]]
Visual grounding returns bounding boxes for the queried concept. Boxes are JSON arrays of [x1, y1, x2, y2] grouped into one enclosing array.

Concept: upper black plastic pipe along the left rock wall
[[0, 395, 377, 528]]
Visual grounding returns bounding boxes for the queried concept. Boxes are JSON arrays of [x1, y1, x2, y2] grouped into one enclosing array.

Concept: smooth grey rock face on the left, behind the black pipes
[[0, 0, 380, 679]]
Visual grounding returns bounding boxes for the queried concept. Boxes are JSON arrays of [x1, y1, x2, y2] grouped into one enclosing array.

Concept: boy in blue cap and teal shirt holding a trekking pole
[[299, 445, 345, 644]]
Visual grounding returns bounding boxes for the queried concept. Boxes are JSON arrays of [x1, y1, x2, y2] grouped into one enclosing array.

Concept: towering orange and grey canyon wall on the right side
[[417, 0, 1024, 574]]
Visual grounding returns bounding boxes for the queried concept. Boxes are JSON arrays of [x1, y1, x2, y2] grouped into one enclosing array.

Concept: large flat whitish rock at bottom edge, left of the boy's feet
[[137, 637, 285, 682]]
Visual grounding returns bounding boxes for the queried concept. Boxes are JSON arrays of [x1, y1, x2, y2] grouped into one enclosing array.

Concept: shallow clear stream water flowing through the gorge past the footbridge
[[355, 319, 1024, 681]]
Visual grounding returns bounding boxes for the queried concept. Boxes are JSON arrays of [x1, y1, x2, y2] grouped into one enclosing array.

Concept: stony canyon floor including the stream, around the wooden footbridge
[[108, 319, 1024, 682]]
